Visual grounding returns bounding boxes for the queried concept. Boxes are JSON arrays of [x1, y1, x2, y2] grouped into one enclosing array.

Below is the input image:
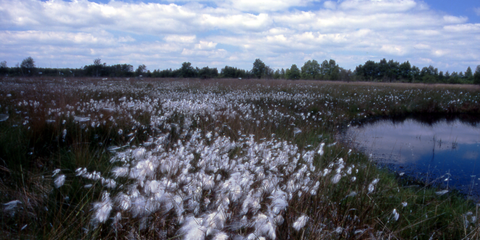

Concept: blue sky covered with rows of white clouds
[[0, 0, 480, 73]]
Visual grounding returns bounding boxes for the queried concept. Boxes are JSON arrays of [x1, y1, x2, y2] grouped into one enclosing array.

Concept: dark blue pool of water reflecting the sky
[[343, 118, 480, 197]]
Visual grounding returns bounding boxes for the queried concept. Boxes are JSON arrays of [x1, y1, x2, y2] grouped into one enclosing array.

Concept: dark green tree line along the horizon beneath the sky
[[0, 57, 480, 84]]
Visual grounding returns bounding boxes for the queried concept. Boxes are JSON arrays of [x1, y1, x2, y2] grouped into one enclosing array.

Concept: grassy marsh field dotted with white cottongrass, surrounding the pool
[[0, 78, 480, 239]]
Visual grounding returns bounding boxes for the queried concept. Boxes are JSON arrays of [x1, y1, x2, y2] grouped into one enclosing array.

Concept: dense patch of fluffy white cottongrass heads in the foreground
[[72, 130, 354, 239]]
